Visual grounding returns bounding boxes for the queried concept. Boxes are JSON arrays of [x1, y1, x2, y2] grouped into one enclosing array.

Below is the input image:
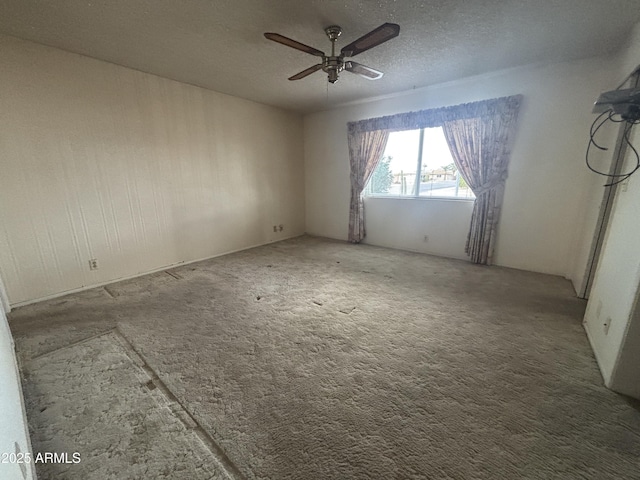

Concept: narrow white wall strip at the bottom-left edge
[[0, 308, 35, 480]]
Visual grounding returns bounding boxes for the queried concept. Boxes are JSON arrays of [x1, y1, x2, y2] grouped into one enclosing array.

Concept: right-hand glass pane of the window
[[420, 127, 475, 198]]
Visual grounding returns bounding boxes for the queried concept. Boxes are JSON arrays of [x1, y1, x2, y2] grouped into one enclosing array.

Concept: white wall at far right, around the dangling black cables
[[584, 24, 640, 398]]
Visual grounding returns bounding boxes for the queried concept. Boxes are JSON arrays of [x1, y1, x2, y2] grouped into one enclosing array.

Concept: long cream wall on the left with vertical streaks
[[0, 36, 304, 305]]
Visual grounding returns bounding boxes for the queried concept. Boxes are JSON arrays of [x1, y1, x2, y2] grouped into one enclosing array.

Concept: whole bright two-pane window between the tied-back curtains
[[365, 127, 475, 199]]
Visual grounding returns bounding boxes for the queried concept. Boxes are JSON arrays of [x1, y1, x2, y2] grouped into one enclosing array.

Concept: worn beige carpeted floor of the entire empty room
[[10, 236, 640, 479]]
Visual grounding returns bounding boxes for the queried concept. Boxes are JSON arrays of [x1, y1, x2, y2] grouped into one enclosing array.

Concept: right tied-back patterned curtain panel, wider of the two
[[442, 97, 521, 265]]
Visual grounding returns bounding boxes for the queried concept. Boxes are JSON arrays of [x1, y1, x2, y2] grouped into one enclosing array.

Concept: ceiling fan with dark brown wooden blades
[[264, 23, 400, 83]]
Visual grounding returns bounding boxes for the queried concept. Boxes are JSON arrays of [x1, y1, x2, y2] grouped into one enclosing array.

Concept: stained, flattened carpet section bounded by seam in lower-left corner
[[24, 333, 230, 480]]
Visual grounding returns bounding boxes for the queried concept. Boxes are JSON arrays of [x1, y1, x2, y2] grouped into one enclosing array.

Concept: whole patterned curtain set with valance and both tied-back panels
[[348, 95, 523, 255]]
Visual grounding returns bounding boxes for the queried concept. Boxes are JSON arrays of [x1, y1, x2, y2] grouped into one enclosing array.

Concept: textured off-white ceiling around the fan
[[0, 0, 640, 112]]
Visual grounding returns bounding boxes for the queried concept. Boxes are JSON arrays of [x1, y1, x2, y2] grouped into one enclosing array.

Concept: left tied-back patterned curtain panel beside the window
[[349, 128, 389, 243]]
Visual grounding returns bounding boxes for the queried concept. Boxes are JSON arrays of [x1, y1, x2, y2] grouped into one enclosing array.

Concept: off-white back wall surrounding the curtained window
[[304, 57, 619, 281]]
